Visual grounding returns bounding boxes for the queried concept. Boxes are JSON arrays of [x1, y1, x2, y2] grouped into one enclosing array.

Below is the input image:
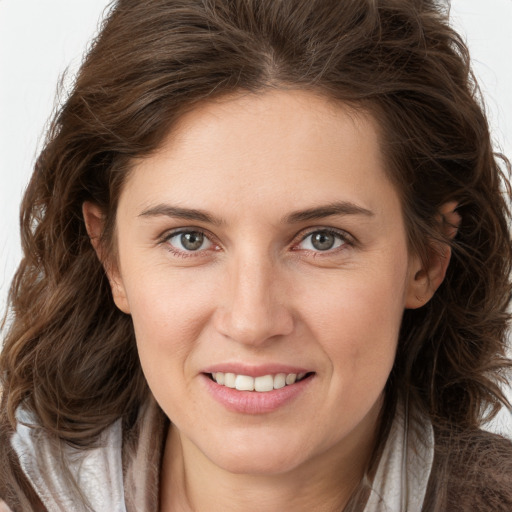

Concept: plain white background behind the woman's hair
[[0, 0, 512, 430]]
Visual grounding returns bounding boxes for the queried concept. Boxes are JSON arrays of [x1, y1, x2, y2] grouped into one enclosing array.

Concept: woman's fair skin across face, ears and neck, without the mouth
[[84, 91, 453, 512]]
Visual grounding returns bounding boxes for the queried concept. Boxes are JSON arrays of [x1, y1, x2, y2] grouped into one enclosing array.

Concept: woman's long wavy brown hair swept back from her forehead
[[0, 0, 512, 508]]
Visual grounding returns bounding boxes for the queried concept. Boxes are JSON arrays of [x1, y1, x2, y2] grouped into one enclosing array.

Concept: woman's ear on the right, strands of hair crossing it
[[405, 201, 461, 309]]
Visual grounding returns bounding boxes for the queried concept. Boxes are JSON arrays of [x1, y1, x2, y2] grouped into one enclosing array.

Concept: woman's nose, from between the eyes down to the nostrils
[[215, 252, 294, 346]]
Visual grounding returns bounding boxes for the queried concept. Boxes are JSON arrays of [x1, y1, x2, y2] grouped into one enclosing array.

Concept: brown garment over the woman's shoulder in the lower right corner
[[424, 429, 512, 512]]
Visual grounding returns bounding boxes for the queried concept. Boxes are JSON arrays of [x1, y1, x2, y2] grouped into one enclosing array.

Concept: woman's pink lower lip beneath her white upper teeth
[[202, 374, 313, 414]]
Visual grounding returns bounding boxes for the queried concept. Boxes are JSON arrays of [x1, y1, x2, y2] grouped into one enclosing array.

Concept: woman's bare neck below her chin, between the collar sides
[[160, 406, 378, 512]]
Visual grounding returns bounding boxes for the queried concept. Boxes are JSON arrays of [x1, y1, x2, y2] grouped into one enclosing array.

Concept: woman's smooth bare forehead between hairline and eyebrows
[[121, 90, 396, 224]]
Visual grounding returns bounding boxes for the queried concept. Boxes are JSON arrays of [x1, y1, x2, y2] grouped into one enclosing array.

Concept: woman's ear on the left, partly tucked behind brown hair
[[82, 201, 130, 314]]
